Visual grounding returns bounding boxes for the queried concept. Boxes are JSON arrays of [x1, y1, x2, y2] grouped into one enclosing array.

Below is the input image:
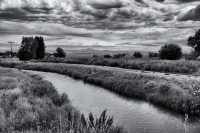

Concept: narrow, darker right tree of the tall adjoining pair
[[35, 36, 46, 59]]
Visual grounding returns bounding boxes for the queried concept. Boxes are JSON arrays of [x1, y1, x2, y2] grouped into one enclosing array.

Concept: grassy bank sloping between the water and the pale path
[[0, 62, 200, 115]]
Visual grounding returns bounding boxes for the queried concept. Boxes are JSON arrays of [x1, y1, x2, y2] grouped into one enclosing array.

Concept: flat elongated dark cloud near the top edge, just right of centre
[[91, 2, 123, 9]]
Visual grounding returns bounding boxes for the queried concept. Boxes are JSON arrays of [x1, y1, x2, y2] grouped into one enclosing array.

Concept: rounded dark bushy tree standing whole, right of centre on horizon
[[159, 44, 182, 60]]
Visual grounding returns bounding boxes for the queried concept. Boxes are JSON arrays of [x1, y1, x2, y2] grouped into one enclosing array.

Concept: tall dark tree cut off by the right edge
[[187, 29, 200, 55]]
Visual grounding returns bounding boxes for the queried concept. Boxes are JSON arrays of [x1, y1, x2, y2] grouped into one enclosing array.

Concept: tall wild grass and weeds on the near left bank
[[0, 68, 124, 133]]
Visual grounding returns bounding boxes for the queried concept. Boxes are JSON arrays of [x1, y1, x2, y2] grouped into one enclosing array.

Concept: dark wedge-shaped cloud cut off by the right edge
[[177, 4, 200, 21]]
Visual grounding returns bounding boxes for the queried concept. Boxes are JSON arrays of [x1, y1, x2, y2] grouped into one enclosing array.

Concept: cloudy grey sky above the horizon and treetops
[[0, 0, 200, 51]]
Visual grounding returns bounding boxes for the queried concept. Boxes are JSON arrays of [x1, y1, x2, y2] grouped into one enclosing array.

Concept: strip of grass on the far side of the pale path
[[34, 56, 200, 74]]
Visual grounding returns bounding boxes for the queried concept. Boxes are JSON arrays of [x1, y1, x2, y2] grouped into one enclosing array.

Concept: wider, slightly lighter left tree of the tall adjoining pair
[[18, 37, 38, 60]]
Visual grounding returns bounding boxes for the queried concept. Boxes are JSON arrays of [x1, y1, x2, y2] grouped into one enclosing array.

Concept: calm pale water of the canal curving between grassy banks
[[25, 71, 200, 133]]
